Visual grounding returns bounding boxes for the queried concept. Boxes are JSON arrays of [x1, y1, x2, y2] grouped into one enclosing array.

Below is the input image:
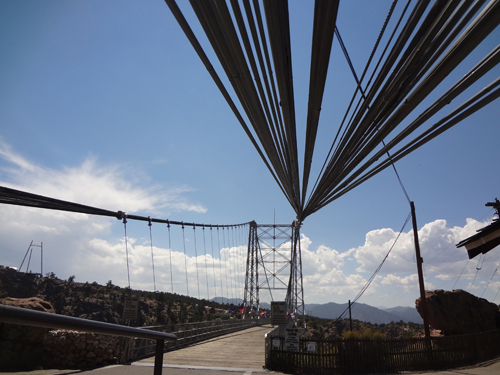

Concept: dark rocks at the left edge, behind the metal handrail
[[0, 297, 54, 370]]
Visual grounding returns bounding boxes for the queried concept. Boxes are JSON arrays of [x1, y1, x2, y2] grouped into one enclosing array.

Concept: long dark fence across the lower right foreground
[[266, 330, 500, 374]]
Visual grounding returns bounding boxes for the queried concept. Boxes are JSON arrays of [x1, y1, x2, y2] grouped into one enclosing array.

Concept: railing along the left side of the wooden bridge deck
[[126, 318, 271, 361]]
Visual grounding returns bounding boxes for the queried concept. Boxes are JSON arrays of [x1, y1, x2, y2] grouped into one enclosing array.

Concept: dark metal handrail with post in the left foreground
[[0, 305, 177, 375]]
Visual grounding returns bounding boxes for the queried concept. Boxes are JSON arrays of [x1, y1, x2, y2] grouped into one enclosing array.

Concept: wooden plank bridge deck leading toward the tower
[[136, 325, 272, 370]]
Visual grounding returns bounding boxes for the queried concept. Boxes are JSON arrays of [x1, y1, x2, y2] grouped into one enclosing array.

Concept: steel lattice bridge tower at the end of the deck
[[243, 221, 304, 324]]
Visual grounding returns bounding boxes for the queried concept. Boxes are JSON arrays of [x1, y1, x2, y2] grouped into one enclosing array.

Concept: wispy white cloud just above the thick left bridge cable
[[0, 141, 206, 214]]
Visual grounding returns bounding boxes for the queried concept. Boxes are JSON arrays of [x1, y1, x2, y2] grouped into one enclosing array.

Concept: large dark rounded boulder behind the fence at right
[[415, 289, 500, 336]]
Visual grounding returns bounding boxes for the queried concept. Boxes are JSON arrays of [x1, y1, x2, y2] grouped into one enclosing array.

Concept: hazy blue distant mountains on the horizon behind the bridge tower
[[212, 297, 423, 324]]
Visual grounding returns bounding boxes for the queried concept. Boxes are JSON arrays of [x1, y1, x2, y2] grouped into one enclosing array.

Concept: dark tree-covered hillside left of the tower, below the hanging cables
[[0, 266, 242, 327]]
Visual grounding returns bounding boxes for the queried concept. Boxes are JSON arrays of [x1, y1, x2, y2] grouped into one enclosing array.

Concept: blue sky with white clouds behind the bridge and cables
[[0, 0, 500, 307]]
